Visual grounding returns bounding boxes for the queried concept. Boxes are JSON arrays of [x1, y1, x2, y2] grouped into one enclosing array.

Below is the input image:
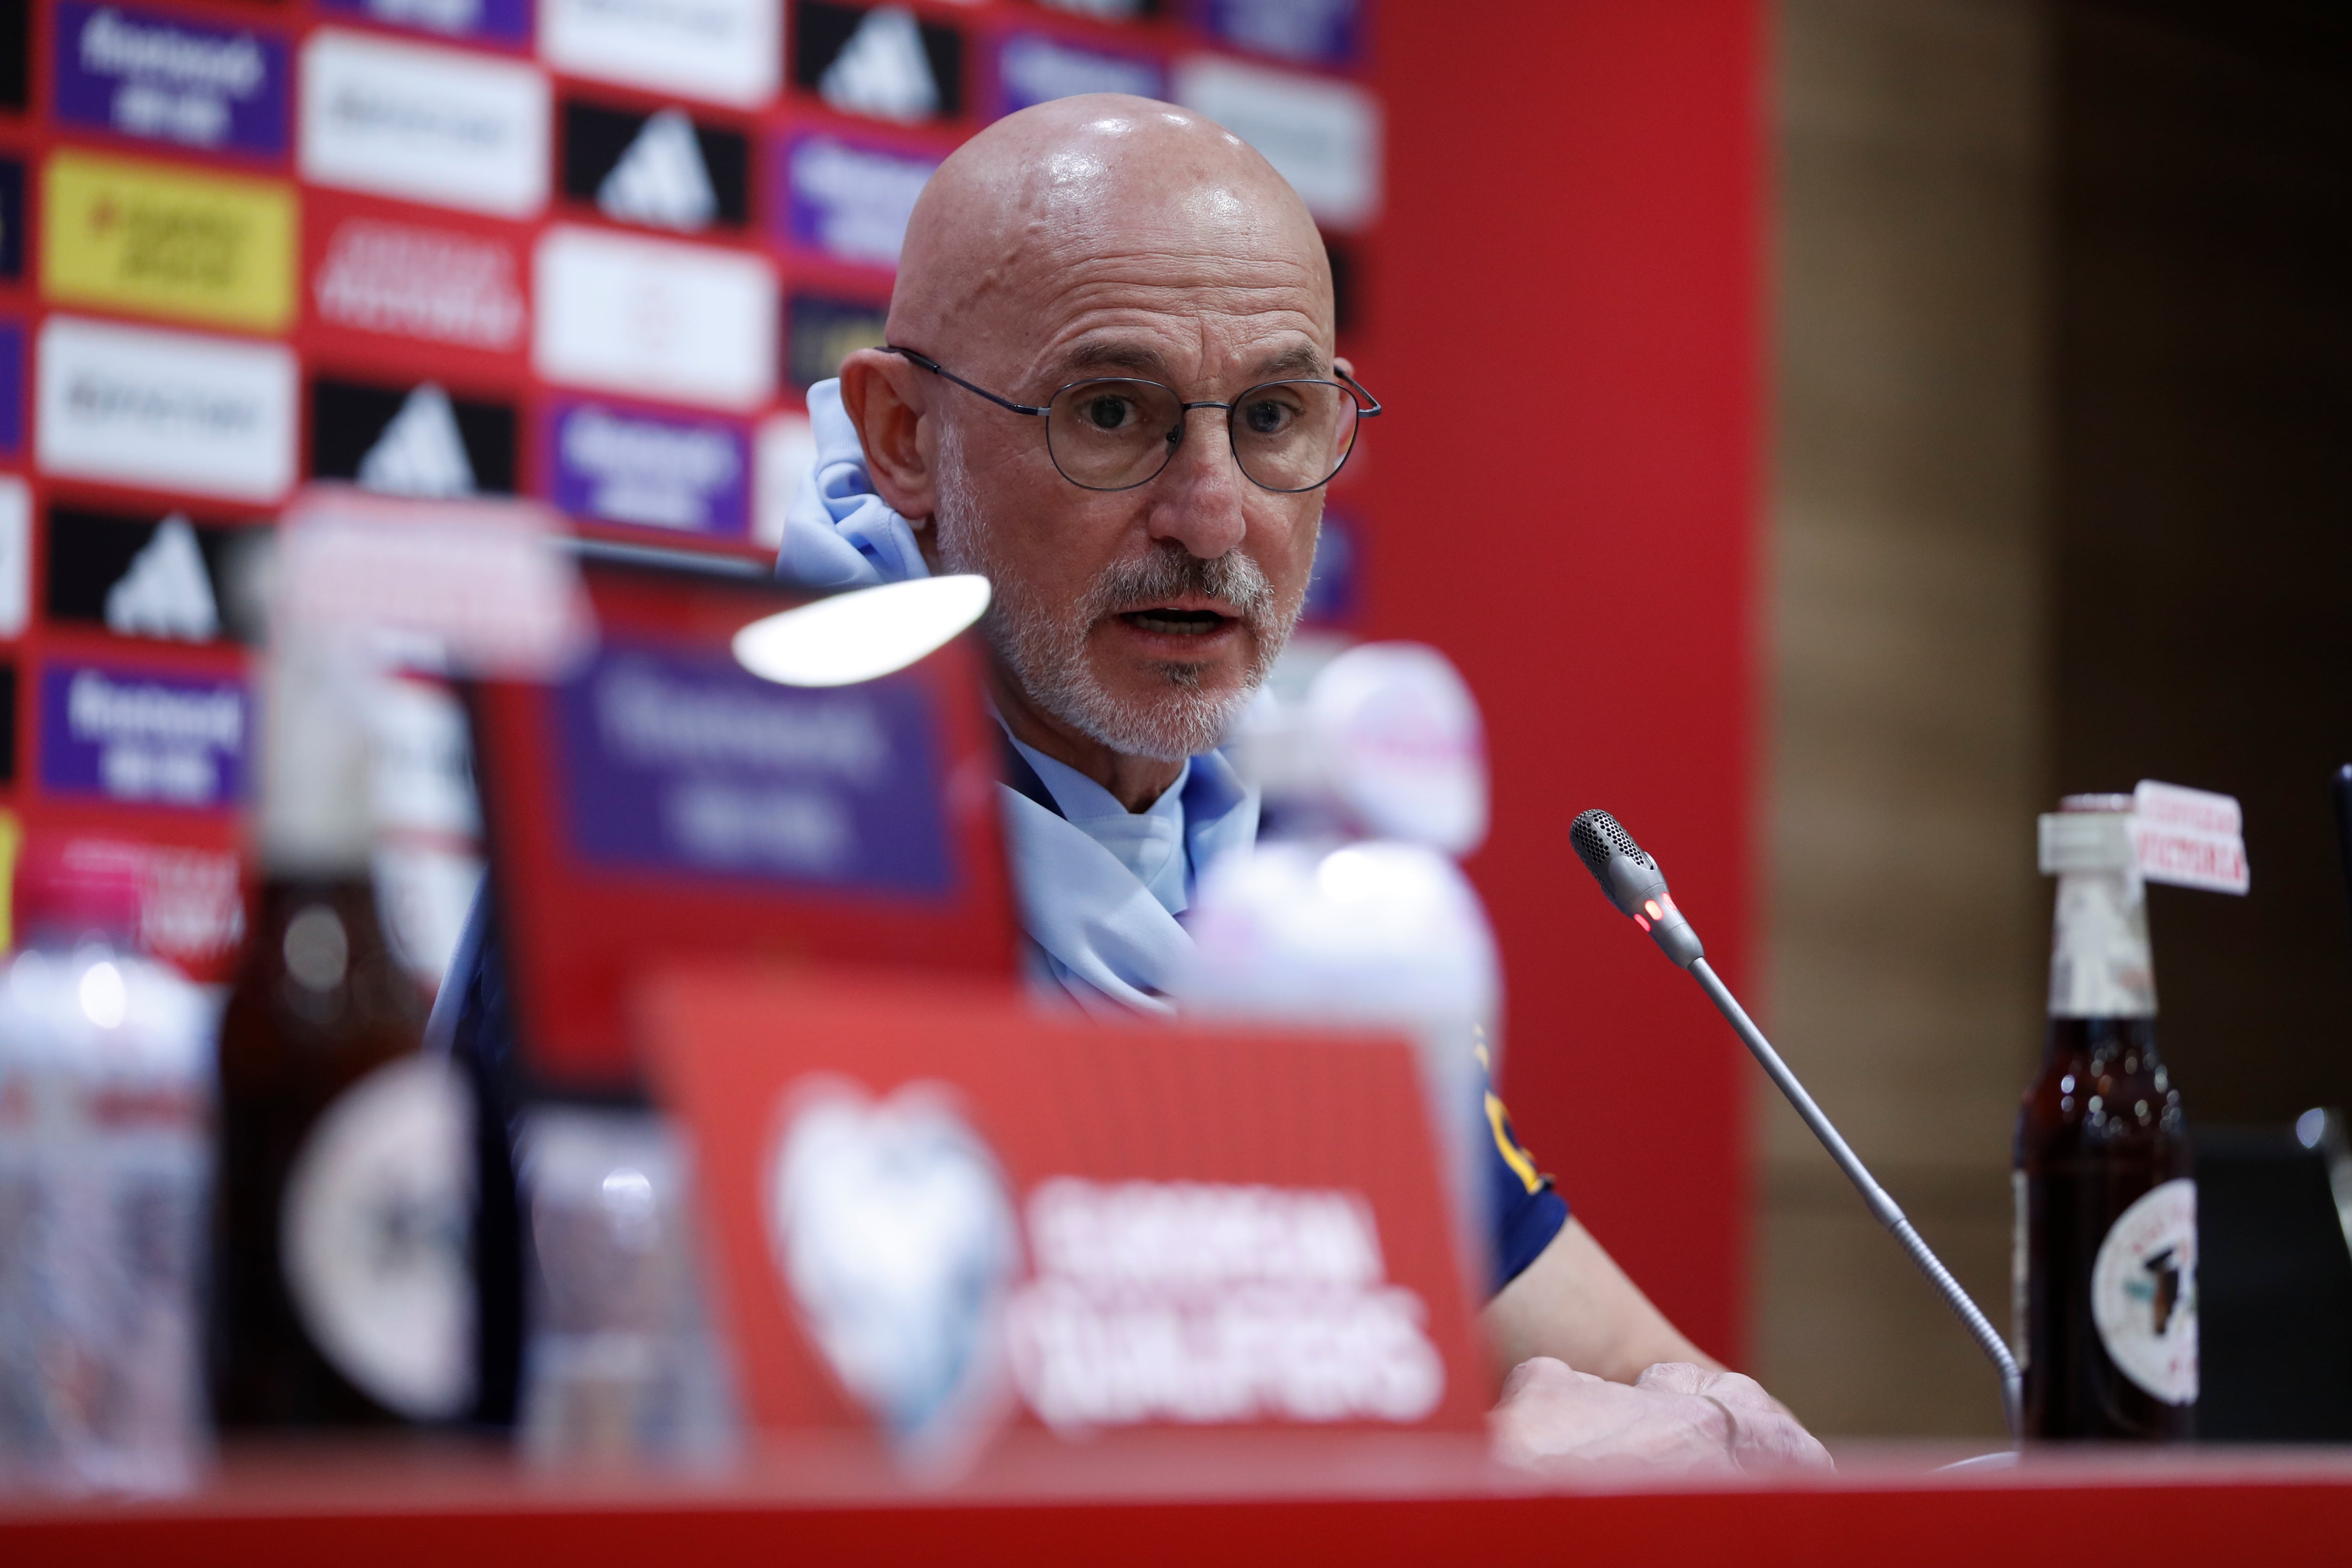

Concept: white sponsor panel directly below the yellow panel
[[33, 315, 299, 501]]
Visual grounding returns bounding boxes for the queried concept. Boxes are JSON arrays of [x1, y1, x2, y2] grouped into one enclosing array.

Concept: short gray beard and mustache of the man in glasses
[[934, 432, 1305, 762]]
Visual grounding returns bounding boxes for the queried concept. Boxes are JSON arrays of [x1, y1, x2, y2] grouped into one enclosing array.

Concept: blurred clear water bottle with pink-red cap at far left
[[0, 839, 214, 1493]]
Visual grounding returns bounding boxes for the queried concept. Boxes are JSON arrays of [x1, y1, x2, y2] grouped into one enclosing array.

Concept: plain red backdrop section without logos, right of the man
[[1355, 0, 1764, 1356]]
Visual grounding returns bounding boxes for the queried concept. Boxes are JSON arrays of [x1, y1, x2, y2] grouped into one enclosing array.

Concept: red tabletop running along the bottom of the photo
[[0, 1434, 2352, 1568]]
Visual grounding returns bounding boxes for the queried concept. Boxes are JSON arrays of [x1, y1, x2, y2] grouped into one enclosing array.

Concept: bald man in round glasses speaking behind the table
[[779, 94, 1825, 1467]]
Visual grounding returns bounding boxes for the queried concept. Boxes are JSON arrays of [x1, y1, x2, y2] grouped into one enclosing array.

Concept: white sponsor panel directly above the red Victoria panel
[[301, 28, 548, 219]]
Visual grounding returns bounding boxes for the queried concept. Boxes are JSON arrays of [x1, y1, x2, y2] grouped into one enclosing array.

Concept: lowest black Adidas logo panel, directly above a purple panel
[[45, 505, 268, 642]]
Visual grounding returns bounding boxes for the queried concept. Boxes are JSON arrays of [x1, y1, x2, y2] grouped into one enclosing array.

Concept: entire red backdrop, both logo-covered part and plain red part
[[0, 0, 1759, 1354]]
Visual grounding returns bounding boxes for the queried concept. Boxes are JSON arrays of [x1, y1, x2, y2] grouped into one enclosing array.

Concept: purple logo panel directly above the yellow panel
[[56, 0, 287, 153]]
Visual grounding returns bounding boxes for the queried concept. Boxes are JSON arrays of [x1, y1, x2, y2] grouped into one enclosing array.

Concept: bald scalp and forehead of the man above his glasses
[[889, 92, 1331, 371]]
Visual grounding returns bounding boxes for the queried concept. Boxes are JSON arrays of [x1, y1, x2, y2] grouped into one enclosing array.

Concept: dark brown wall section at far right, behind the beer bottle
[[2049, 0, 2352, 1122]]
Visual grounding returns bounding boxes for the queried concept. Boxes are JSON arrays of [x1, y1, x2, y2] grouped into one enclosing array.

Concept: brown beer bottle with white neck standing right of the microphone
[[2011, 795, 2197, 1441]]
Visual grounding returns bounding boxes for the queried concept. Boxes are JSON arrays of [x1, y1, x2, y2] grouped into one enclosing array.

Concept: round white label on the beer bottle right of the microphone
[[2091, 1180, 2197, 1406]]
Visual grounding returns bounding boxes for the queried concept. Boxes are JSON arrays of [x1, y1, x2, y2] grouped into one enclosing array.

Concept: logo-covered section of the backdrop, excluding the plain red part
[[0, 0, 1381, 978]]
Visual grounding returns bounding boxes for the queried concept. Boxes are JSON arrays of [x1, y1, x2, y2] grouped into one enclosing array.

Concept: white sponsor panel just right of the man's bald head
[[1176, 54, 1381, 228]]
